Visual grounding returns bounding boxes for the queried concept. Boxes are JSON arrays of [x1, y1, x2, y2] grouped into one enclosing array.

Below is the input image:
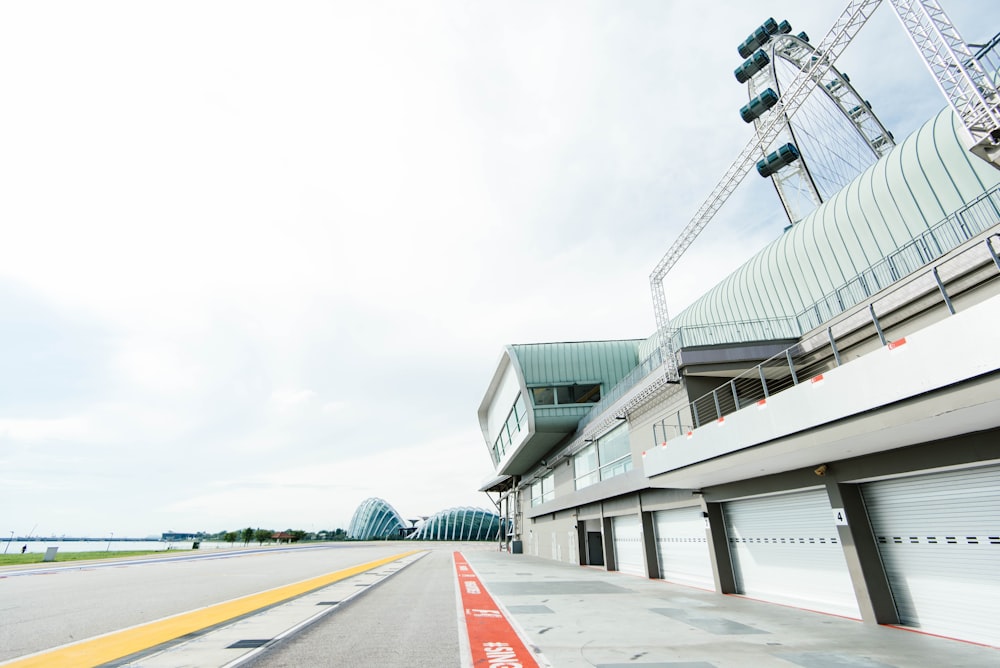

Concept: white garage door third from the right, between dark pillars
[[653, 506, 715, 589]]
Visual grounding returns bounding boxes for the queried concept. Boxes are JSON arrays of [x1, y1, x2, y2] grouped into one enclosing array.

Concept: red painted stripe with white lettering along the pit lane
[[455, 552, 539, 668]]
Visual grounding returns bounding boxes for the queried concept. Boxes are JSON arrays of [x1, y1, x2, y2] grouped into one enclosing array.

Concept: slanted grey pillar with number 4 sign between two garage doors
[[826, 479, 899, 624]]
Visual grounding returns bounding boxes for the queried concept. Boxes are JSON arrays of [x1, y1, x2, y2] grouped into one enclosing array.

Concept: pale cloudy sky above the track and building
[[0, 0, 1000, 538]]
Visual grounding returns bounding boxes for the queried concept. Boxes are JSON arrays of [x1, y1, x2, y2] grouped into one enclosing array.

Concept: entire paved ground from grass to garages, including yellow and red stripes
[[0, 543, 1000, 668]]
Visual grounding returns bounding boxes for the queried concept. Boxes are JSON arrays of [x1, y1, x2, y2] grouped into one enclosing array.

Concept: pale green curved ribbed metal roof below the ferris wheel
[[672, 109, 1000, 334]]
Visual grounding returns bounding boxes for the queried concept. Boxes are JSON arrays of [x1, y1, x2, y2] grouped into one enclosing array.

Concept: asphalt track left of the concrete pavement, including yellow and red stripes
[[0, 543, 538, 668]]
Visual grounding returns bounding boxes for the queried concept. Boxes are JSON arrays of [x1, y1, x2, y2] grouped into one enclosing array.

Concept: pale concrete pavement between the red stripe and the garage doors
[[467, 552, 1000, 668]]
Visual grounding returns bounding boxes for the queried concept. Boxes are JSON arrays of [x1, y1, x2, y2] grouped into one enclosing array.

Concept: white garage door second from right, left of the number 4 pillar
[[723, 489, 861, 618]]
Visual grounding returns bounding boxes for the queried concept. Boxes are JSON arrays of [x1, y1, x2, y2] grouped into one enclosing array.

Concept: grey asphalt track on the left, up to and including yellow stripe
[[0, 543, 454, 668]]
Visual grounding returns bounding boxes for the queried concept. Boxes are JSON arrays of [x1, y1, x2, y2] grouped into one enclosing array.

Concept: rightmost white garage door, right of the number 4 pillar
[[862, 466, 1000, 646]]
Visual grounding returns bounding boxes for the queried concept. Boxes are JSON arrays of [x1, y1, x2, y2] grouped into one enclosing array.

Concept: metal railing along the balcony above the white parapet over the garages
[[653, 234, 1000, 443]]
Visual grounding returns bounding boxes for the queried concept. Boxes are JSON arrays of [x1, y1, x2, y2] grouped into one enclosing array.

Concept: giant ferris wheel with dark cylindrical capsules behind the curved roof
[[734, 18, 894, 224]]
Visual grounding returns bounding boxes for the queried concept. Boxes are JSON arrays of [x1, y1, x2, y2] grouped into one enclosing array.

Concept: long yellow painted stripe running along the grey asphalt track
[[2, 550, 421, 668]]
